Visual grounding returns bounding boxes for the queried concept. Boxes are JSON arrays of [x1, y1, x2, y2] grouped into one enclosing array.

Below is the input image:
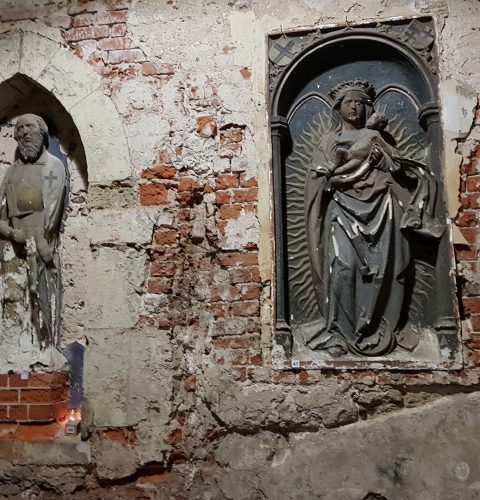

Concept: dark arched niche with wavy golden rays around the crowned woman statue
[[269, 18, 462, 369]]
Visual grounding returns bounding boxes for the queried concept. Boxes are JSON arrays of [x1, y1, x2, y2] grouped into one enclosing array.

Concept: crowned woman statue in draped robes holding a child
[[302, 80, 441, 356]]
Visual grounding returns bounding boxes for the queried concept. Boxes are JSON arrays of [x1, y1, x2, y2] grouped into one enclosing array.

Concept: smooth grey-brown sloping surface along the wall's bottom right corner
[[216, 394, 480, 500]]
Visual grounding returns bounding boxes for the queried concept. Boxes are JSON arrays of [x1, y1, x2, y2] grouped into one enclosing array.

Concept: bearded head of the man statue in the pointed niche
[[13, 114, 48, 163]]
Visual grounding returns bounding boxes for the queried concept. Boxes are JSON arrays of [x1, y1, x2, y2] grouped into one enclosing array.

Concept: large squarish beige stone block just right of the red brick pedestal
[[84, 327, 173, 428]]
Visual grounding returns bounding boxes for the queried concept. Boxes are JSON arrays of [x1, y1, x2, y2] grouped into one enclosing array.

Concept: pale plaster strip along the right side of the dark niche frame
[[439, 77, 478, 245]]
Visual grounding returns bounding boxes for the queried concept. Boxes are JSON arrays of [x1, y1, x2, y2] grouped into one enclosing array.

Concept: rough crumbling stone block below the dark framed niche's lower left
[[205, 377, 358, 432]]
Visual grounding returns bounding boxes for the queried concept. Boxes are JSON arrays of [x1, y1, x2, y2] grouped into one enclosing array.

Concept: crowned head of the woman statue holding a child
[[329, 80, 375, 129]]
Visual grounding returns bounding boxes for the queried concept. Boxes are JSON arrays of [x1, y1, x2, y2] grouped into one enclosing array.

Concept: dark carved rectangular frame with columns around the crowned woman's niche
[[269, 18, 463, 370]]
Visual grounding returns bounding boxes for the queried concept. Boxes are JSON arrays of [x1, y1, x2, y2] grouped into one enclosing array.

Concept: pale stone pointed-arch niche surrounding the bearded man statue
[[0, 30, 131, 373]]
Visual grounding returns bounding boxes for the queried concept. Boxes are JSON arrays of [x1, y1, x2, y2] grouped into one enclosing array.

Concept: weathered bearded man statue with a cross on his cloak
[[0, 114, 66, 347]]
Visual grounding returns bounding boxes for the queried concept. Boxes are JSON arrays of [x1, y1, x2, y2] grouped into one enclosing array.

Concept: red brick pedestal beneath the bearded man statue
[[0, 372, 69, 422]]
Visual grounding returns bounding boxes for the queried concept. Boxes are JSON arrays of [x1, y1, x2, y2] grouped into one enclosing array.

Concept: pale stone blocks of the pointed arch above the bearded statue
[[0, 30, 131, 184]]
